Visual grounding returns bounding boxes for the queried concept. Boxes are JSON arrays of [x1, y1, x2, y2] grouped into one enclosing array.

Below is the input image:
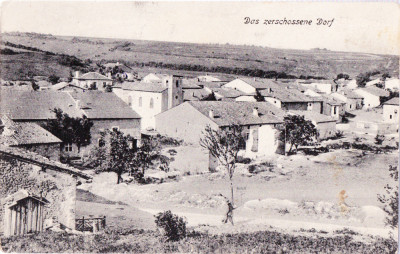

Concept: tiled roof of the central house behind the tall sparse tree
[[186, 101, 284, 126]]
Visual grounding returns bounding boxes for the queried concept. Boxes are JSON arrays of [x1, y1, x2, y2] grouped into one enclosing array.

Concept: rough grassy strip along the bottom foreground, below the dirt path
[[1, 230, 397, 254]]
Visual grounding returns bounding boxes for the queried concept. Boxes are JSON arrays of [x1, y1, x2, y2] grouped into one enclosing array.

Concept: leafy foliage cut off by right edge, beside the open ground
[[378, 165, 399, 228]]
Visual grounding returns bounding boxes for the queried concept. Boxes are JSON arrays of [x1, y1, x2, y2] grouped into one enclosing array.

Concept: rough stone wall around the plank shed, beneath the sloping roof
[[0, 155, 76, 234]]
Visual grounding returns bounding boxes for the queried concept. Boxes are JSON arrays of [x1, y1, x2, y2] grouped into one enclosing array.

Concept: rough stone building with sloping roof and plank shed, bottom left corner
[[0, 145, 91, 236]]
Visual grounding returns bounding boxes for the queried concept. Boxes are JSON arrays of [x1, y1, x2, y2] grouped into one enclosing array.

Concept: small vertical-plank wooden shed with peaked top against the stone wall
[[4, 190, 49, 236]]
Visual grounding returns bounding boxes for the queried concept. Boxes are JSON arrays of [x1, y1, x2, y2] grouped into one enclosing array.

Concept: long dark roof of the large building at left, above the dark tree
[[0, 89, 140, 121]]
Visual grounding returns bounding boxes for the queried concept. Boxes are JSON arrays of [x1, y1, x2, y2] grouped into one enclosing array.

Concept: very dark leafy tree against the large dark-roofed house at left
[[43, 108, 93, 152]]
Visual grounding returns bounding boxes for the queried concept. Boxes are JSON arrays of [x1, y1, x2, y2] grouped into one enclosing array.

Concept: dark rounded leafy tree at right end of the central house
[[279, 115, 317, 154]]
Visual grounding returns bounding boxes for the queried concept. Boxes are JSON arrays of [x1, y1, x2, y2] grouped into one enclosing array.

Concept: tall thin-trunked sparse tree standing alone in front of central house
[[200, 125, 245, 225]]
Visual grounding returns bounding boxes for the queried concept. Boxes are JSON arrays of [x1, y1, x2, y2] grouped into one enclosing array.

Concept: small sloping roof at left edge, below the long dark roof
[[0, 116, 62, 146]]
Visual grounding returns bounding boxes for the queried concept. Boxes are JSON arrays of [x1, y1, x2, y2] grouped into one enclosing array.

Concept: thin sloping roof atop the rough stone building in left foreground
[[0, 145, 92, 179]]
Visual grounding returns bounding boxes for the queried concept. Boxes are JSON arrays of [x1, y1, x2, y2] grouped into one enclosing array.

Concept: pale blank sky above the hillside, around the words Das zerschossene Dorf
[[0, 1, 400, 55]]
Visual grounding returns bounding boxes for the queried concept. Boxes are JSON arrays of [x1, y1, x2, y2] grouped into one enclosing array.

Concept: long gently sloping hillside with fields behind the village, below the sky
[[1, 33, 399, 78]]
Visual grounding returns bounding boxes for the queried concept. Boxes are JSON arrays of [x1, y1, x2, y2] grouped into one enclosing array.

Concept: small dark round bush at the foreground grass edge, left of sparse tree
[[155, 211, 187, 241]]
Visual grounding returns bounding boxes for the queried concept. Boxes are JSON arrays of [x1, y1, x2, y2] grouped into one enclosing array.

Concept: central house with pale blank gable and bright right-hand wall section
[[156, 101, 284, 161]]
